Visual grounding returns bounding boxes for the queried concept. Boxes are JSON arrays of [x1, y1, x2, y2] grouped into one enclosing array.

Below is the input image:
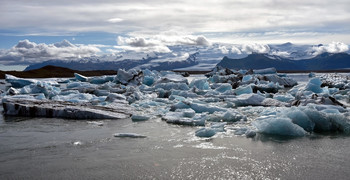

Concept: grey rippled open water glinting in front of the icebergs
[[0, 75, 350, 179]]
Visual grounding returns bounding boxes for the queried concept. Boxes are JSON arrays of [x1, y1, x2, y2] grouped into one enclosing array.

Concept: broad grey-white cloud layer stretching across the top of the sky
[[0, 0, 350, 44]]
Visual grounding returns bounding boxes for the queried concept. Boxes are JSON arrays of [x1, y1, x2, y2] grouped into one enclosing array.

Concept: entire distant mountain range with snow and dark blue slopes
[[25, 43, 350, 71]]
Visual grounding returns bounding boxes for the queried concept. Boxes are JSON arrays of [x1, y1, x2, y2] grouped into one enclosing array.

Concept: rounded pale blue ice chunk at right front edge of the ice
[[252, 116, 306, 136]]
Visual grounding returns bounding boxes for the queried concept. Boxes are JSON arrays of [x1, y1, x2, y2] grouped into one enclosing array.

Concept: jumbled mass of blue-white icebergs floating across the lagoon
[[2, 67, 350, 138]]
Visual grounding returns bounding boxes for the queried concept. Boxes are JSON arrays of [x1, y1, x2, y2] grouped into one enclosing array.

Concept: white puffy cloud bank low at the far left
[[0, 39, 100, 65]]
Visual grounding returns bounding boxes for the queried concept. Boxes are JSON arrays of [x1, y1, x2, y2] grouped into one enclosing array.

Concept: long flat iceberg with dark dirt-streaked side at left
[[2, 97, 131, 119]]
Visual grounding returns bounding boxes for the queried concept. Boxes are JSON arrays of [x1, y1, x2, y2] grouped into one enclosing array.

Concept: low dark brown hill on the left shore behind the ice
[[0, 66, 117, 79]]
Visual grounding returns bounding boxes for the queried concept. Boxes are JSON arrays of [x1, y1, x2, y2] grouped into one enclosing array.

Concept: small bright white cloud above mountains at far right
[[309, 42, 349, 55]]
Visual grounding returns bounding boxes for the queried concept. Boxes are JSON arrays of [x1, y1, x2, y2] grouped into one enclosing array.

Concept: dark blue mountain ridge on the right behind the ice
[[217, 53, 350, 71]]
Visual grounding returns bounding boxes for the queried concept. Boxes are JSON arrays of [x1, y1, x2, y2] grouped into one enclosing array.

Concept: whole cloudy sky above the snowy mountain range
[[0, 0, 350, 69]]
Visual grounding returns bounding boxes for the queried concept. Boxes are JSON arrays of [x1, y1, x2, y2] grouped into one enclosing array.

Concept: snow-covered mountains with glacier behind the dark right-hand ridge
[[25, 42, 349, 70]]
